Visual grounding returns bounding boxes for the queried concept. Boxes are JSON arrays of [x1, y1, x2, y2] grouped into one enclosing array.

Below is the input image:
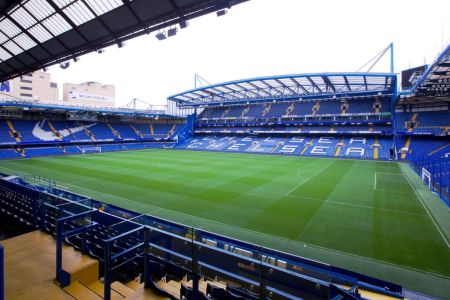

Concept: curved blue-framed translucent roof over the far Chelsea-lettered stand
[[167, 73, 397, 107]]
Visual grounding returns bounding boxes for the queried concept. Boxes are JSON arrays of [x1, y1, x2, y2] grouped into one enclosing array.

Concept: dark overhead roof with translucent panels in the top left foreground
[[0, 0, 248, 82]]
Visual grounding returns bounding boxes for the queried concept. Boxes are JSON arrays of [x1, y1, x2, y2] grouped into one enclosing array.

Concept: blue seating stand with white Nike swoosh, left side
[[0, 113, 186, 159]]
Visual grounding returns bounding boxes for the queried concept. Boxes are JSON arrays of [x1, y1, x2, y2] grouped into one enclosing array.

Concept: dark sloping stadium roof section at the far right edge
[[402, 44, 450, 97]]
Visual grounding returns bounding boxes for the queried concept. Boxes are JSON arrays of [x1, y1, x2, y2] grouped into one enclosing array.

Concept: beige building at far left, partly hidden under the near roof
[[0, 71, 59, 103]]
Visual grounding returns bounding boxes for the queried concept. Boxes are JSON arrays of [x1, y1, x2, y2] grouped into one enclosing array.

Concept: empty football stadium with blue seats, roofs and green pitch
[[0, 0, 450, 300]]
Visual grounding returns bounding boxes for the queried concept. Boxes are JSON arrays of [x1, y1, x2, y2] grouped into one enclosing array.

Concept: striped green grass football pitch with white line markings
[[0, 150, 450, 297]]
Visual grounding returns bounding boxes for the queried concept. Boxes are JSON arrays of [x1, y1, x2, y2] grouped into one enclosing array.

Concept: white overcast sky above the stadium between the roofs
[[50, 0, 450, 106]]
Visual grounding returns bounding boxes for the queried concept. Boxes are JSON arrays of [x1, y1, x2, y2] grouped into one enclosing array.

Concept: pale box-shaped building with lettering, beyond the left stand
[[63, 81, 115, 108]]
